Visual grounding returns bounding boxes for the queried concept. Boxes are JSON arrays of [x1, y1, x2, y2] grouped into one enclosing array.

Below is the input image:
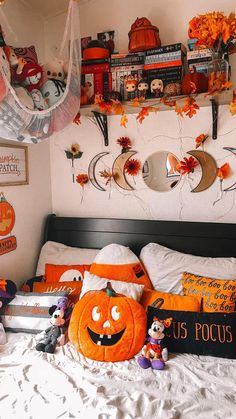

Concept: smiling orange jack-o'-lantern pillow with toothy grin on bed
[[69, 282, 146, 362]]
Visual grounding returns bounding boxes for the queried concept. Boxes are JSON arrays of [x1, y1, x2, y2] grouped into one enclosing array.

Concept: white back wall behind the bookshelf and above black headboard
[[45, 0, 236, 222]]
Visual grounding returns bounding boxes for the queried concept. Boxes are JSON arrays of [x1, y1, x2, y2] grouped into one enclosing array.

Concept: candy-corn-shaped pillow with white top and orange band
[[90, 243, 153, 289]]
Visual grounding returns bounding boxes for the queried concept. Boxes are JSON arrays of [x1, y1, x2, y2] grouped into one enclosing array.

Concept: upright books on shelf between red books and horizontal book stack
[[111, 52, 145, 100]]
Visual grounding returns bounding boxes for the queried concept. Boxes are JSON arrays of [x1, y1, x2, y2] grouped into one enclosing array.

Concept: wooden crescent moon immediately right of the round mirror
[[187, 150, 217, 192]]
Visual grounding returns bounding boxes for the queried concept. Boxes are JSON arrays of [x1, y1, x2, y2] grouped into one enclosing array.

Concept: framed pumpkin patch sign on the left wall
[[0, 144, 29, 186]]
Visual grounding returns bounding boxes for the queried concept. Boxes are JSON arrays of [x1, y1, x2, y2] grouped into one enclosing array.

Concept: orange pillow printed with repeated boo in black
[[182, 272, 236, 313]]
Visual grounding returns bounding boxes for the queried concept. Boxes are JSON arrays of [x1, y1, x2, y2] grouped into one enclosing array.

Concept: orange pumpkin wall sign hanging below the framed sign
[[0, 192, 17, 256]]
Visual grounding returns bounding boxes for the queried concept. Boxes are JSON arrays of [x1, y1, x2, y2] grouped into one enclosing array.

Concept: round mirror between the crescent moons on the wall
[[142, 151, 182, 192]]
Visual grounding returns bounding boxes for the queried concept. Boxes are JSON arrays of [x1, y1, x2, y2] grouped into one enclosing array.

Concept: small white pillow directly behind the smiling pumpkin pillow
[[80, 271, 144, 301]]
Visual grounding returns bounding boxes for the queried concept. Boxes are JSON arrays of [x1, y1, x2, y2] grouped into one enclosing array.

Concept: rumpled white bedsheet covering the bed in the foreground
[[0, 333, 236, 419]]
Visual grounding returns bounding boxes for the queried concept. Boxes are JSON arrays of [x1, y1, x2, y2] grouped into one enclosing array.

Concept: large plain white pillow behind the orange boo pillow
[[140, 243, 236, 294]]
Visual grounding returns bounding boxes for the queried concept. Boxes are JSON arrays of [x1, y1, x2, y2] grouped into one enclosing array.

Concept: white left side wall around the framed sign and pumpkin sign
[[0, 0, 51, 284]]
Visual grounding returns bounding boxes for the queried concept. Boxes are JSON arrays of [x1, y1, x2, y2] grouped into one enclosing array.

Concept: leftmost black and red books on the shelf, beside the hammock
[[81, 58, 112, 103]]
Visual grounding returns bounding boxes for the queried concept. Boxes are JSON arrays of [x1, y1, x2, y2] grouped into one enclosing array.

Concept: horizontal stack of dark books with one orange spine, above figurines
[[144, 42, 187, 95]]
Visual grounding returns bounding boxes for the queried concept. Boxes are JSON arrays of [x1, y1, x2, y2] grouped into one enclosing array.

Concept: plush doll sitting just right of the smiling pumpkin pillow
[[138, 317, 173, 370]]
